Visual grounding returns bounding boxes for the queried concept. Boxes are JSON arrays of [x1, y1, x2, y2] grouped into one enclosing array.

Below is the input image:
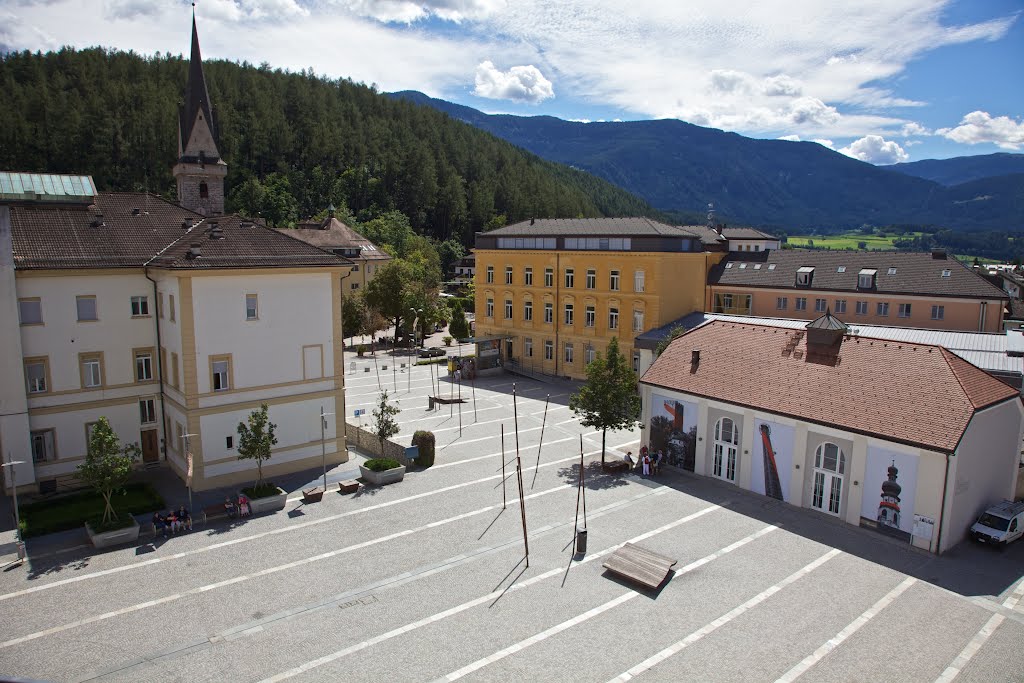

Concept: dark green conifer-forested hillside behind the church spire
[[0, 48, 655, 245]]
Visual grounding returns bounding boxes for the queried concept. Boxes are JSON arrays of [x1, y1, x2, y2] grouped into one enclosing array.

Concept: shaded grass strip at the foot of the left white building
[[20, 483, 165, 539]]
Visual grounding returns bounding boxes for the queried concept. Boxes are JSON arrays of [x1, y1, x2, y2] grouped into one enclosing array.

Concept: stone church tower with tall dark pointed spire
[[174, 13, 227, 216]]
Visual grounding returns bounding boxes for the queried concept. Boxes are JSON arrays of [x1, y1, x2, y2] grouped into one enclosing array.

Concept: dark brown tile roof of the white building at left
[[10, 193, 349, 270]]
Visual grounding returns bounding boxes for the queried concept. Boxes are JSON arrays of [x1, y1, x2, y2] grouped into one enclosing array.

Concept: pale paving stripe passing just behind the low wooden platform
[[254, 505, 729, 683]]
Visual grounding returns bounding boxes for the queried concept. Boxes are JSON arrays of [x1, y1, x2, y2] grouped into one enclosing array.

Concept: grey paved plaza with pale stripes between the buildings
[[0, 356, 1024, 682]]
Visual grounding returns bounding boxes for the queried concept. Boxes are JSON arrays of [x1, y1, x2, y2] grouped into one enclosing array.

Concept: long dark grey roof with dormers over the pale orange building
[[708, 249, 1008, 299]]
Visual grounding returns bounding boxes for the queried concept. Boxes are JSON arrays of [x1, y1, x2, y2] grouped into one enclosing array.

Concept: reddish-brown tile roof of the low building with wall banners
[[641, 321, 1020, 453]]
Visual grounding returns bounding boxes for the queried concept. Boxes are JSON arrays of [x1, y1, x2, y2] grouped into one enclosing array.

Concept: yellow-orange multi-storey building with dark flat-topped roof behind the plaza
[[474, 218, 727, 379]]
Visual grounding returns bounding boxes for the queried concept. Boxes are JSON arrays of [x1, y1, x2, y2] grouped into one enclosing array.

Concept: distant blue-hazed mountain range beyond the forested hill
[[390, 91, 1024, 230]]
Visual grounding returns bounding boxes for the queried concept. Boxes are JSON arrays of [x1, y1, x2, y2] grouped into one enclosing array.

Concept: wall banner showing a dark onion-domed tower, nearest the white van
[[860, 446, 918, 541]]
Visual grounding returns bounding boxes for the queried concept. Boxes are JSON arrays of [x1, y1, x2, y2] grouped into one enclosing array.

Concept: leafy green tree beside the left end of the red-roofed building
[[569, 337, 640, 465]]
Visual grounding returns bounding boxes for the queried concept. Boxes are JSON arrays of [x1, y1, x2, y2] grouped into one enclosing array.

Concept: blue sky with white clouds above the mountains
[[0, 0, 1024, 164]]
